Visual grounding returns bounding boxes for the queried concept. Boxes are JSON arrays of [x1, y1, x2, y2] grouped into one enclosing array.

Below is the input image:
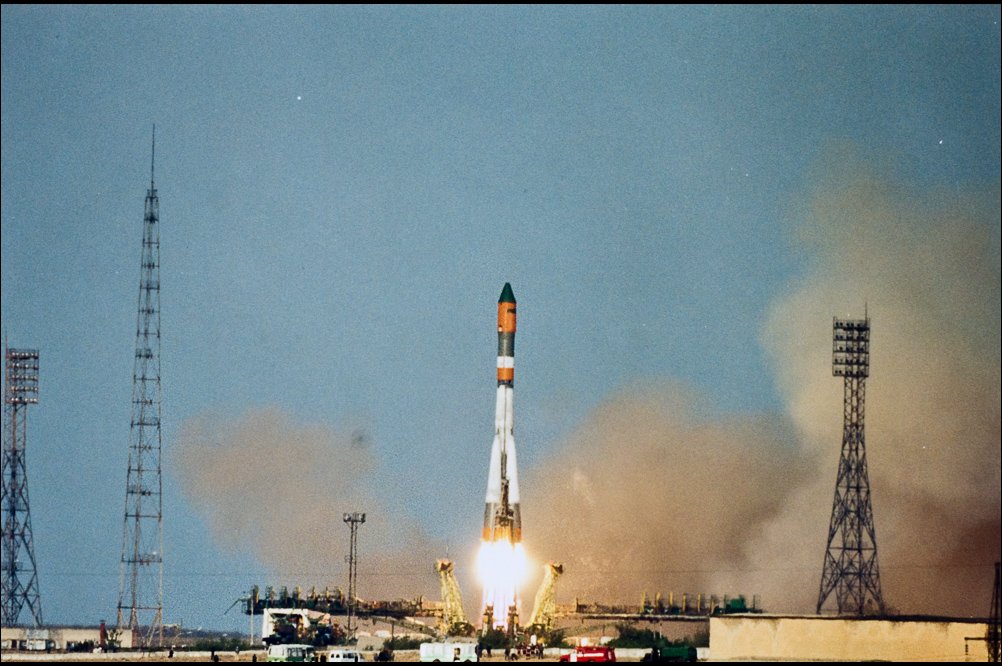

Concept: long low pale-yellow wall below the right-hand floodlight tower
[[709, 615, 988, 661]]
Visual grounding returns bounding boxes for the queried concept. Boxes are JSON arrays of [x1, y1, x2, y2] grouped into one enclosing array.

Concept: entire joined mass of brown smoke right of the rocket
[[523, 157, 1000, 615]]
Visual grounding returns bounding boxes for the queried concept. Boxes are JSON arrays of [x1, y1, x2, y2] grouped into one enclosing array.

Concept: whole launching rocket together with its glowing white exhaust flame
[[477, 282, 526, 627]]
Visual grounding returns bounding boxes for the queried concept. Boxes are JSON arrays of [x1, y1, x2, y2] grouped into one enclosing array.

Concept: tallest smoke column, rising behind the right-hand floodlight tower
[[760, 155, 1002, 615]]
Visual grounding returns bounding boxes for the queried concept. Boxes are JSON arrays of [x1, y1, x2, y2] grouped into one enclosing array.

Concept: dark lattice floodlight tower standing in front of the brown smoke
[[818, 317, 884, 615]]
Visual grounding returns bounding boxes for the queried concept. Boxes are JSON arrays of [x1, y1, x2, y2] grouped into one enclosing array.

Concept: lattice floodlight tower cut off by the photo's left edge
[[2, 349, 42, 627]]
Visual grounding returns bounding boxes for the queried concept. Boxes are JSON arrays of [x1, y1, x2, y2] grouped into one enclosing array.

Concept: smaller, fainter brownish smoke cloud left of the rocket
[[173, 409, 439, 599]]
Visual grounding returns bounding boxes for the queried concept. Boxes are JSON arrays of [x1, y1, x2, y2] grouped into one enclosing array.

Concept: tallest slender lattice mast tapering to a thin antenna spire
[[118, 127, 163, 646]]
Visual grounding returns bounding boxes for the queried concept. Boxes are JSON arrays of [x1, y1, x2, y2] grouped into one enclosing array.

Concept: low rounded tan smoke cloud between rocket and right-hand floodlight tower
[[524, 385, 814, 604]]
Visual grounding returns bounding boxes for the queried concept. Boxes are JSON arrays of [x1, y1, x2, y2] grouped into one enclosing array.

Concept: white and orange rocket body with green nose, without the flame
[[483, 282, 522, 544]]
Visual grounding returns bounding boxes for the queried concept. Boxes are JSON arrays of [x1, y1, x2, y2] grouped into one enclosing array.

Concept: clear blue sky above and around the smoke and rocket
[[0, 5, 1000, 629]]
